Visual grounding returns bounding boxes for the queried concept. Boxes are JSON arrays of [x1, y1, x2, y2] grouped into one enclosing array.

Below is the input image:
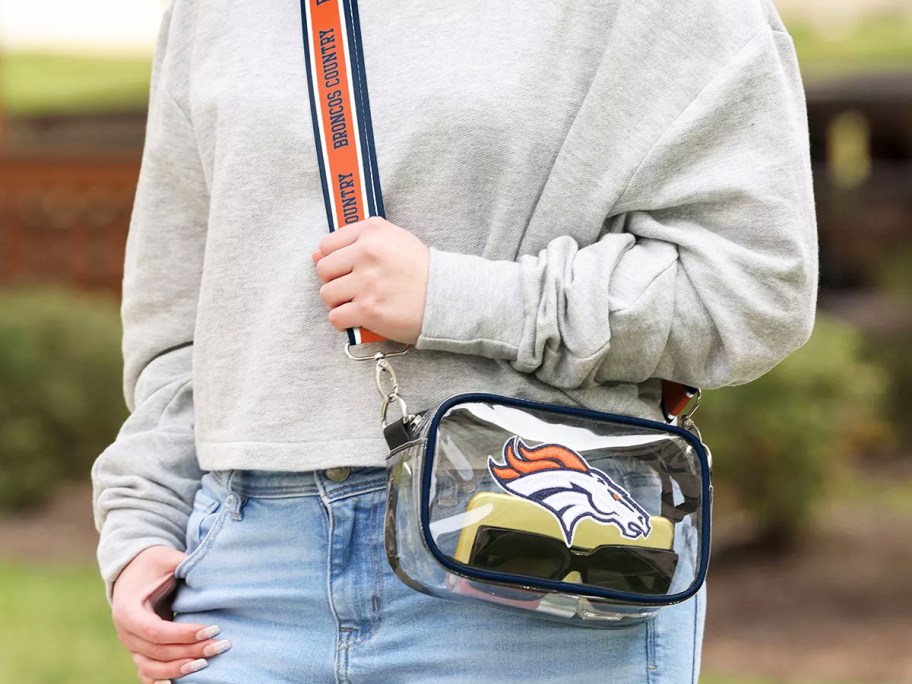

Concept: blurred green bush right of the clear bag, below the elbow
[[697, 315, 890, 548]]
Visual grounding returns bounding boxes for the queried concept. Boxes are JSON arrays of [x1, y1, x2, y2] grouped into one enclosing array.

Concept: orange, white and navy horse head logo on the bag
[[488, 436, 652, 546]]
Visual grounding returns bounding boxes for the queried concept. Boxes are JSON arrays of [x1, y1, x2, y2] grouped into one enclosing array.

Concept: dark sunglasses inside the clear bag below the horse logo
[[468, 526, 678, 597]]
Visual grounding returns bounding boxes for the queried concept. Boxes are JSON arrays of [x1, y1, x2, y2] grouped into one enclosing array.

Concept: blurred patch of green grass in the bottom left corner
[[0, 562, 137, 684]]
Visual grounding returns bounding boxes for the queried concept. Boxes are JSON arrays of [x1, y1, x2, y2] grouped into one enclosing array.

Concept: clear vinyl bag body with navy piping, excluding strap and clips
[[388, 395, 710, 626]]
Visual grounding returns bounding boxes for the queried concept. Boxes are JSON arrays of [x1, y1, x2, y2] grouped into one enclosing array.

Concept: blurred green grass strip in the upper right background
[[785, 11, 912, 75]]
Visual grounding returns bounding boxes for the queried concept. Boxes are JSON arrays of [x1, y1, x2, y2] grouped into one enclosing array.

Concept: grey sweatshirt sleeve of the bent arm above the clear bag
[[416, 27, 817, 389]]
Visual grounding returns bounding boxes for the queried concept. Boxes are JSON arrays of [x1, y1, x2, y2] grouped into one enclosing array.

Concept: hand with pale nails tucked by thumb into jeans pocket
[[111, 546, 231, 684]]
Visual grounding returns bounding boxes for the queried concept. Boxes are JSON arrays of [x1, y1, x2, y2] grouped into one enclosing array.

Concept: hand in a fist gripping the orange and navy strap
[[311, 217, 430, 344]]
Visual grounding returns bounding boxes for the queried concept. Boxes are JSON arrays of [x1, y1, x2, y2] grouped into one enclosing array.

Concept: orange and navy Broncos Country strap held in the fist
[[301, 0, 386, 345]]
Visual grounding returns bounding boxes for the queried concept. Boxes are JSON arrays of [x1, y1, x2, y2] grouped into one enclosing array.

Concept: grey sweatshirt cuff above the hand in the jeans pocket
[[97, 511, 185, 604]]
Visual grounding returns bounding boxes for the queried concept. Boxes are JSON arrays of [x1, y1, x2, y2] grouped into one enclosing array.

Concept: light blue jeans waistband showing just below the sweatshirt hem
[[211, 468, 386, 499]]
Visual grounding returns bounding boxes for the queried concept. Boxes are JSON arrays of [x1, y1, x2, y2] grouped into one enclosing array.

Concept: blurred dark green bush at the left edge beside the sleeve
[[0, 286, 127, 510]]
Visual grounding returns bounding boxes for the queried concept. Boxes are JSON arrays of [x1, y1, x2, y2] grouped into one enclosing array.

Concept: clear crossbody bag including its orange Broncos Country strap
[[302, 0, 712, 627]]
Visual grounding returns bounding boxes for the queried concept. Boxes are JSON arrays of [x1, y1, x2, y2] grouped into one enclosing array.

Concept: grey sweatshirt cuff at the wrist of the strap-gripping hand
[[415, 247, 524, 361]]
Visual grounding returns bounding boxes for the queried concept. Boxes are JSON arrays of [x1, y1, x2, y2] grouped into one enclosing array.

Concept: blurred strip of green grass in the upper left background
[[0, 52, 152, 116]]
